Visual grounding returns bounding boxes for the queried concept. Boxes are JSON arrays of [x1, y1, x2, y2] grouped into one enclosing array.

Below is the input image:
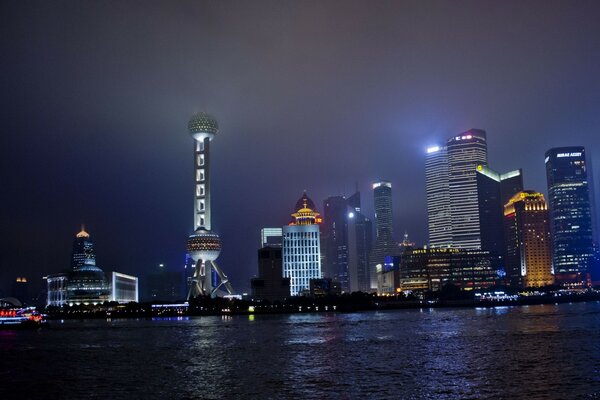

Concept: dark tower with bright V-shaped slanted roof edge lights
[[476, 165, 523, 256]]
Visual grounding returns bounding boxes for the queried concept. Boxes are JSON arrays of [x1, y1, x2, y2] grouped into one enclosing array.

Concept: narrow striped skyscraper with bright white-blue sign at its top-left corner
[[425, 146, 452, 248]]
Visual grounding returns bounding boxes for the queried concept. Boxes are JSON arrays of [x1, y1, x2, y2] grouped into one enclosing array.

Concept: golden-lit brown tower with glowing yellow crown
[[504, 190, 554, 287]]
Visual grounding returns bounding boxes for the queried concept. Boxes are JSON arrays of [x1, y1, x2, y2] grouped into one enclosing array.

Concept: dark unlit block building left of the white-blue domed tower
[[250, 246, 290, 301]]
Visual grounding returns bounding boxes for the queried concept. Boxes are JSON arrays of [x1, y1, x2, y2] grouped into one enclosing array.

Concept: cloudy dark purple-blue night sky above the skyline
[[0, 0, 600, 294]]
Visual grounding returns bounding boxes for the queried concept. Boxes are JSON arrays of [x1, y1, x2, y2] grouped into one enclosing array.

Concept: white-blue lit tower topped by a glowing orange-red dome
[[283, 192, 323, 296]]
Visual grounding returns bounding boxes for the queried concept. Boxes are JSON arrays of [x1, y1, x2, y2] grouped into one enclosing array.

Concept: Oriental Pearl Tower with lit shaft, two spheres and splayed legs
[[187, 112, 233, 299]]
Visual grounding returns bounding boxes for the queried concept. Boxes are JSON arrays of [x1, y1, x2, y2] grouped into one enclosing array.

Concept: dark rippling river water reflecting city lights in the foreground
[[0, 302, 600, 399]]
